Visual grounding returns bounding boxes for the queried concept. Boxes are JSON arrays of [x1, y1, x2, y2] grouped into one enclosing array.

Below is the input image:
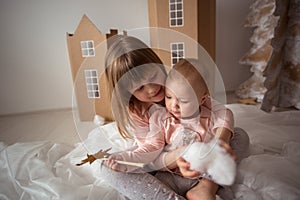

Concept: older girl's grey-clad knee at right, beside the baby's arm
[[230, 127, 250, 163]]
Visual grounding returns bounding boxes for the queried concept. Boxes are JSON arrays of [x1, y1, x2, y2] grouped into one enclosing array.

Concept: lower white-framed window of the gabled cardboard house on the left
[[84, 69, 100, 99]]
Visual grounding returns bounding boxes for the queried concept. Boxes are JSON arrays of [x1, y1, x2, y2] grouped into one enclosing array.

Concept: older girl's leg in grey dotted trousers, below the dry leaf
[[100, 166, 185, 200]]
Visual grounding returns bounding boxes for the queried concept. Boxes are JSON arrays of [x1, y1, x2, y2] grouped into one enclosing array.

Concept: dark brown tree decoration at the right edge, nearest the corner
[[261, 0, 300, 112]]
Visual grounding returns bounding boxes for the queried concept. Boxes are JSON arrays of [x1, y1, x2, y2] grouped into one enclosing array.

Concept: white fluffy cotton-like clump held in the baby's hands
[[183, 140, 237, 185]]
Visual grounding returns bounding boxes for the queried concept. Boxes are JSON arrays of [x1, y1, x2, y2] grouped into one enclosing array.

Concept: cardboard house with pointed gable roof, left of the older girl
[[66, 15, 118, 121]]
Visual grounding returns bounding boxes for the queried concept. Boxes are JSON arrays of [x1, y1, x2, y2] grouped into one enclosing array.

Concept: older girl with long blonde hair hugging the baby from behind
[[101, 36, 184, 199]]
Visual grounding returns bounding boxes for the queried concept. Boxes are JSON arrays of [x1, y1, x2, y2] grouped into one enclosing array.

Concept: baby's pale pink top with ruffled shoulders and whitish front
[[149, 99, 234, 171]]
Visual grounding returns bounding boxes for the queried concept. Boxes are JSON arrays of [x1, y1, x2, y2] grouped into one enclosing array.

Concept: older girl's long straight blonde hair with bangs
[[105, 35, 167, 138]]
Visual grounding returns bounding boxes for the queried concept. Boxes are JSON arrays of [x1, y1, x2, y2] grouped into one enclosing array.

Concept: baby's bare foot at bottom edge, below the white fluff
[[186, 178, 219, 200]]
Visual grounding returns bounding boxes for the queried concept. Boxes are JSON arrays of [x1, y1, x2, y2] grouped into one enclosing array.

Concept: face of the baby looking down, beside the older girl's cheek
[[165, 77, 199, 119]]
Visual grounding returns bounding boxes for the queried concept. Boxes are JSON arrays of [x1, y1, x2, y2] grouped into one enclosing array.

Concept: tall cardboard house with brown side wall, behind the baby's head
[[148, 0, 216, 67]]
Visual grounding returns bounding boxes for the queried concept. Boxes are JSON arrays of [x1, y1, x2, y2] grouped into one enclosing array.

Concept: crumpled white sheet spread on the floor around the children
[[0, 104, 300, 200]]
